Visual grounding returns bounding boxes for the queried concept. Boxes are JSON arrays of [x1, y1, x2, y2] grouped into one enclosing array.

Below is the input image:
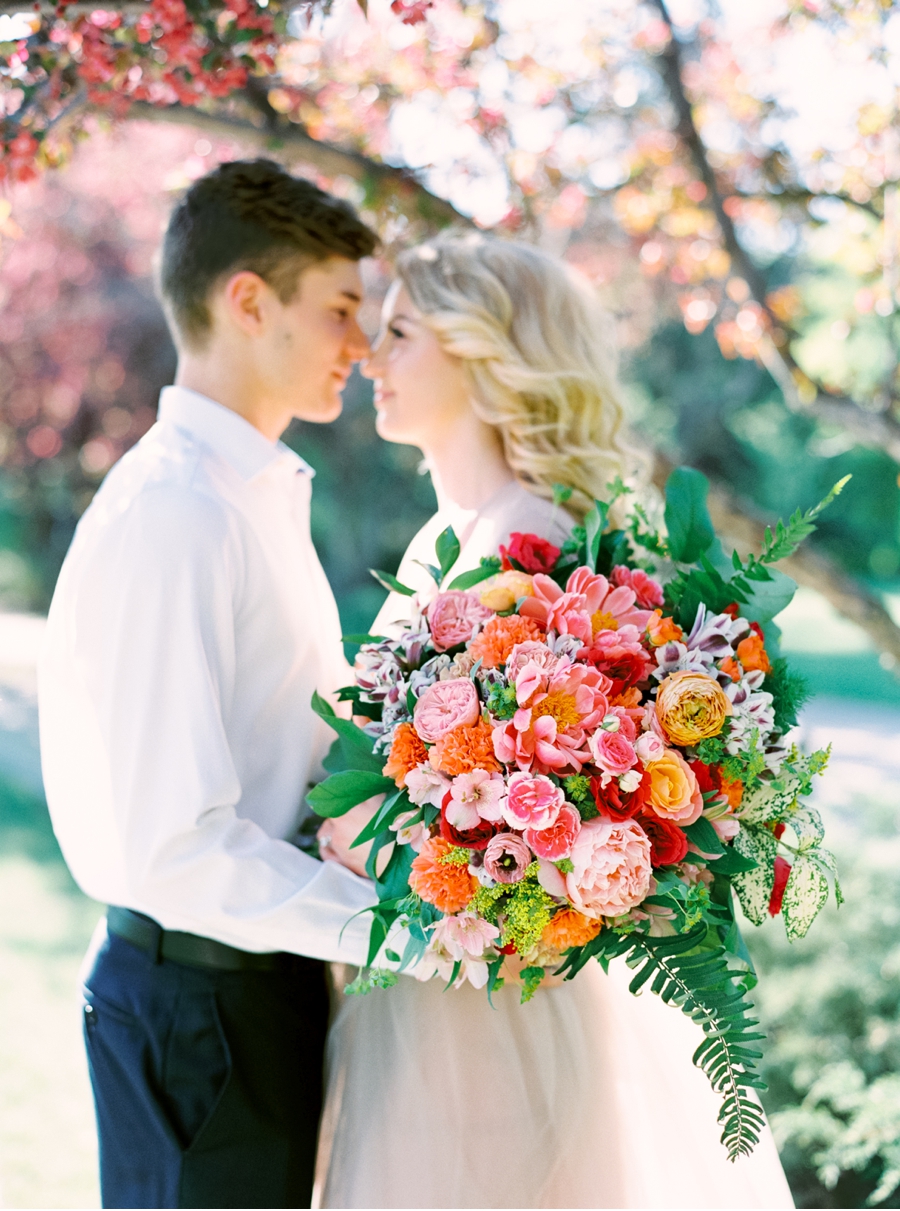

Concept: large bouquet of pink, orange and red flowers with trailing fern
[[309, 467, 845, 1157]]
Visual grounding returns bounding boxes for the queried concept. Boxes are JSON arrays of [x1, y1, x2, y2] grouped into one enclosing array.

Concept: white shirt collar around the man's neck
[[159, 386, 315, 481]]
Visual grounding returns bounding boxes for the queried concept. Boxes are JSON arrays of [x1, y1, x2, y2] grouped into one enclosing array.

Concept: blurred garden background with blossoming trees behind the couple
[[0, 0, 900, 1207]]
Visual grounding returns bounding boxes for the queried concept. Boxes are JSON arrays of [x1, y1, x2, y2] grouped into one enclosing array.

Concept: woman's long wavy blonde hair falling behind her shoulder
[[397, 233, 640, 521]]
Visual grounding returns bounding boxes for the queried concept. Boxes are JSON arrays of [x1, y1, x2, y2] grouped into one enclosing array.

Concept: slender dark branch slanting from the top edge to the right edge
[[650, 0, 900, 461]]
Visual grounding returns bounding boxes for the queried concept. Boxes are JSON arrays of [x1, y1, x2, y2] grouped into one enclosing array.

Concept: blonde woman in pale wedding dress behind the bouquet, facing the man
[[319, 235, 793, 1207]]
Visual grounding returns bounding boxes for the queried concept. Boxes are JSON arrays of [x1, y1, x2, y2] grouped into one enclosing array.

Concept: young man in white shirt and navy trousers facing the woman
[[40, 160, 376, 1207]]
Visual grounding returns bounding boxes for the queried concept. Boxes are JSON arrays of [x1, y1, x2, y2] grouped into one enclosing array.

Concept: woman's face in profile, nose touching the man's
[[361, 282, 471, 449]]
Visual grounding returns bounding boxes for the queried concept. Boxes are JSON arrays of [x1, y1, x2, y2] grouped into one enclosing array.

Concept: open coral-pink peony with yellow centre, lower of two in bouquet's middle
[[493, 656, 609, 774]]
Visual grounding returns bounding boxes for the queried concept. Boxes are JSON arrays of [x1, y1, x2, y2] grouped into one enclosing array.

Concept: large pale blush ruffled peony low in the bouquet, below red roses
[[566, 816, 650, 918]]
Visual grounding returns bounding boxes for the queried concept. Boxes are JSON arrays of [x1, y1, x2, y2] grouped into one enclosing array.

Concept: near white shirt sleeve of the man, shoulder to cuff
[[40, 486, 376, 964]]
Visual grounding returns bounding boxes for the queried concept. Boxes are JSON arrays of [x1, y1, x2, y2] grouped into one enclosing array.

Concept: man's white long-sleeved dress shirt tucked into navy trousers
[[39, 388, 376, 963]]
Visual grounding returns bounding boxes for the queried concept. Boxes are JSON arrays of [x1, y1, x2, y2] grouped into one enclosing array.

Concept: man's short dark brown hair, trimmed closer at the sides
[[160, 160, 378, 346]]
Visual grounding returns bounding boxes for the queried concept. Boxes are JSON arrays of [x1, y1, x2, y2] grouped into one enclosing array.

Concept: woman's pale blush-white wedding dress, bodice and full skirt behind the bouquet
[[314, 484, 793, 1207]]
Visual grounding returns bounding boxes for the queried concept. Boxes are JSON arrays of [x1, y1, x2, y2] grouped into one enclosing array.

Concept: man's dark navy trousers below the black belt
[[82, 920, 328, 1207]]
